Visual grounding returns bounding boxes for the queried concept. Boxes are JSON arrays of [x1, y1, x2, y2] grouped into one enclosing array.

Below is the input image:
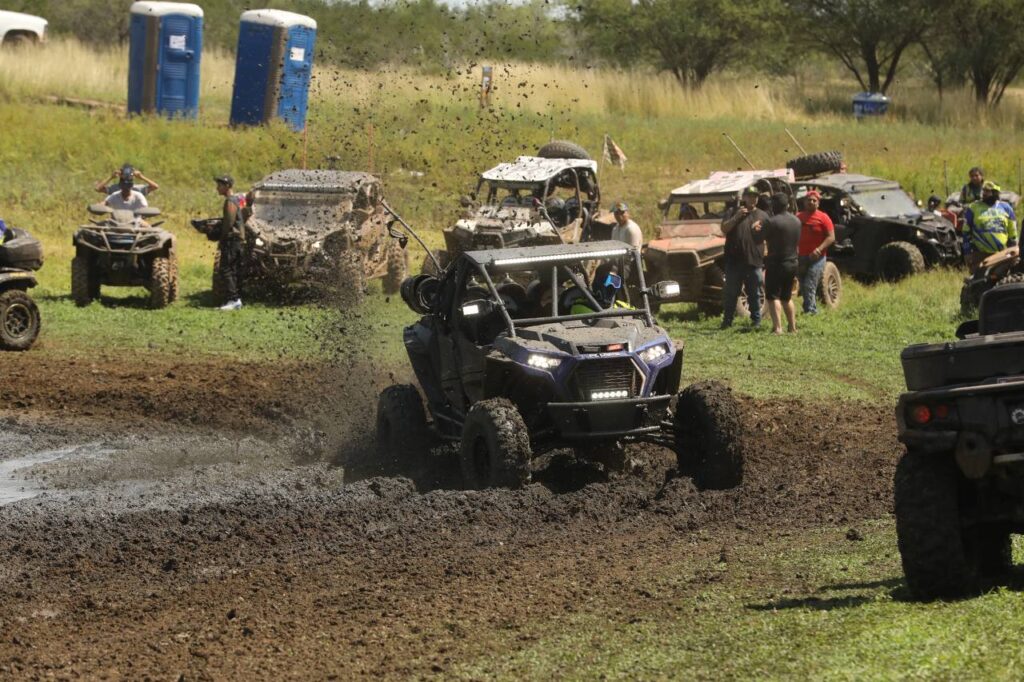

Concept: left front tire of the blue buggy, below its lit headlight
[[459, 398, 534, 489]]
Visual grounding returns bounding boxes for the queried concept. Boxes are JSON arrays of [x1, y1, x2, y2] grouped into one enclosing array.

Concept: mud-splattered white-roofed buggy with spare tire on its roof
[[423, 142, 611, 274]]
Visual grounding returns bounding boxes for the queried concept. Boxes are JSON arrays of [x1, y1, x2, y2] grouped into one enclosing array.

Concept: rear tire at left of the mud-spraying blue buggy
[[377, 384, 431, 474]]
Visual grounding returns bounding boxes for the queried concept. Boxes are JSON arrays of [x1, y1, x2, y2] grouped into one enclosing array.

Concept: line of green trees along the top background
[[8, 0, 1024, 106]]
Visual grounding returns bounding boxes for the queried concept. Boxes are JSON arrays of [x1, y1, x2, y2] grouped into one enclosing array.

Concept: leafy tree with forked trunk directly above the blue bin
[[788, 0, 934, 92]]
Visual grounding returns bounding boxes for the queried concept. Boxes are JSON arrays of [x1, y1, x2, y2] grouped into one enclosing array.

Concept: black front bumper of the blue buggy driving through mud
[[547, 395, 672, 440]]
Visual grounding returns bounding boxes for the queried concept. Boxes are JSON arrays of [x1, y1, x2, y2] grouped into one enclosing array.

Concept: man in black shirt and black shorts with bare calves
[[754, 191, 801, 334]]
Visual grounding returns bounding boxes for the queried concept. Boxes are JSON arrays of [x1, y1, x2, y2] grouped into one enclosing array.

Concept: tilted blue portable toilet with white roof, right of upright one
[[231, 9, 316, 130]]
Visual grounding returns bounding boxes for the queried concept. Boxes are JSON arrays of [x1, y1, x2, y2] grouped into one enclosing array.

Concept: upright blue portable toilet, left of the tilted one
[[128, 2, 203, 119]]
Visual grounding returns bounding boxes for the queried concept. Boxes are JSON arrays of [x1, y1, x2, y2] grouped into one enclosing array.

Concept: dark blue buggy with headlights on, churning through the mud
[[377, 241, 743, 488]]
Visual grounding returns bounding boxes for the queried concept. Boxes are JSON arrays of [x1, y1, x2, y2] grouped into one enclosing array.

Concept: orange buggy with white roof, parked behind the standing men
[[643, 169, 843, 315]]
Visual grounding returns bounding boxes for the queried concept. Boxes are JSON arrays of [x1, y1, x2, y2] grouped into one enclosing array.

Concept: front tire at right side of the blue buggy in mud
[[675, 381, 743, 491]]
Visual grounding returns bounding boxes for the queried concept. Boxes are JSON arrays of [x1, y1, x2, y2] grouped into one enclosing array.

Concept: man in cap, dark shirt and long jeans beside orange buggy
[[722, 185, 768, 329]]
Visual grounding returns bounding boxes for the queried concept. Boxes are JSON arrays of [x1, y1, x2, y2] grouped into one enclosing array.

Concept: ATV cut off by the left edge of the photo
[[0, 227, 43, 350]]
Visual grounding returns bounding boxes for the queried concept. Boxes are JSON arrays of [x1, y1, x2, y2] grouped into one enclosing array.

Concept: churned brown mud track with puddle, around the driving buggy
[[0, 355, 898, 679]]
